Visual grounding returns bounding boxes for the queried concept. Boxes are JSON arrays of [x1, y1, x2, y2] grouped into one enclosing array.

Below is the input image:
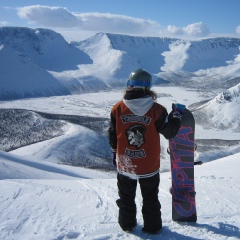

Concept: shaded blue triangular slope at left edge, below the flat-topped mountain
[[0, 45, 70, 100]]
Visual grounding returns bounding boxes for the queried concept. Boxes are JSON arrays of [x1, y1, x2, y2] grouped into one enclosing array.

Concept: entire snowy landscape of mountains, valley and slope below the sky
[[0, 27, 240, 240]]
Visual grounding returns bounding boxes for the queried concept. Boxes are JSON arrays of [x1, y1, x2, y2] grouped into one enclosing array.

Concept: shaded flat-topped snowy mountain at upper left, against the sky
[[0, 27, 92, 72]]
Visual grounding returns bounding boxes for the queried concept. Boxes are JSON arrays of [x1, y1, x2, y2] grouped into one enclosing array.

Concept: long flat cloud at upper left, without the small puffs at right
[[17, 5, 161, 34]]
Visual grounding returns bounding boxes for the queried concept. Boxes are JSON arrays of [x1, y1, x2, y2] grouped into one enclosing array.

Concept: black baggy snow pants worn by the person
[[116, 173, 162, 232]]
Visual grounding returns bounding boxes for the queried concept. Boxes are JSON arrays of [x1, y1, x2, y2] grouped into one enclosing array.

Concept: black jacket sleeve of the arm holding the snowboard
[[155, 108, 181, 139]]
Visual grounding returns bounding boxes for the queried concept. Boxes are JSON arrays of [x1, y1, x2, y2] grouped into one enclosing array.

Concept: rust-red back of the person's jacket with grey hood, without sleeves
[[112, 89, 164, 177]]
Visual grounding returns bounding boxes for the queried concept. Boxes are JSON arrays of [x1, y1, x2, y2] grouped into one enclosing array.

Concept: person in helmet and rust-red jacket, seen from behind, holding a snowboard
[[108, 69, 183, 234]]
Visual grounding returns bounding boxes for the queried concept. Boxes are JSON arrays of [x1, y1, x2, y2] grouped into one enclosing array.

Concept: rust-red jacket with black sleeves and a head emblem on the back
[[108, 90, 180, 176]]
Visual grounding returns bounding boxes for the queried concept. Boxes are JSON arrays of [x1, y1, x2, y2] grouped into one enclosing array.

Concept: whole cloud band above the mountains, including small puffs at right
[[17, 5, 209, 37]]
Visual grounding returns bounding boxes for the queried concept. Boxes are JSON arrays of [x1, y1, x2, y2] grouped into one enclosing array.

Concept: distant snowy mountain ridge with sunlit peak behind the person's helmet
[[72, 33, 240, 82]]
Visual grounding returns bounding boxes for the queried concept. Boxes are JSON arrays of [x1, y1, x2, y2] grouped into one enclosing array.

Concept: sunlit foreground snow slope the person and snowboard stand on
[[0, 152, 240, 240]]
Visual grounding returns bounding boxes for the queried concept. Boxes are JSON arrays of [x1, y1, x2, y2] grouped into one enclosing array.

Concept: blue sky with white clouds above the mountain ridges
[[0, 0, 240, 41]]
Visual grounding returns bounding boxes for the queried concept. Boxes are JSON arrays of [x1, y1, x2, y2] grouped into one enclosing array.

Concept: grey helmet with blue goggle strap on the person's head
[[127, 69, 152, 88]]
